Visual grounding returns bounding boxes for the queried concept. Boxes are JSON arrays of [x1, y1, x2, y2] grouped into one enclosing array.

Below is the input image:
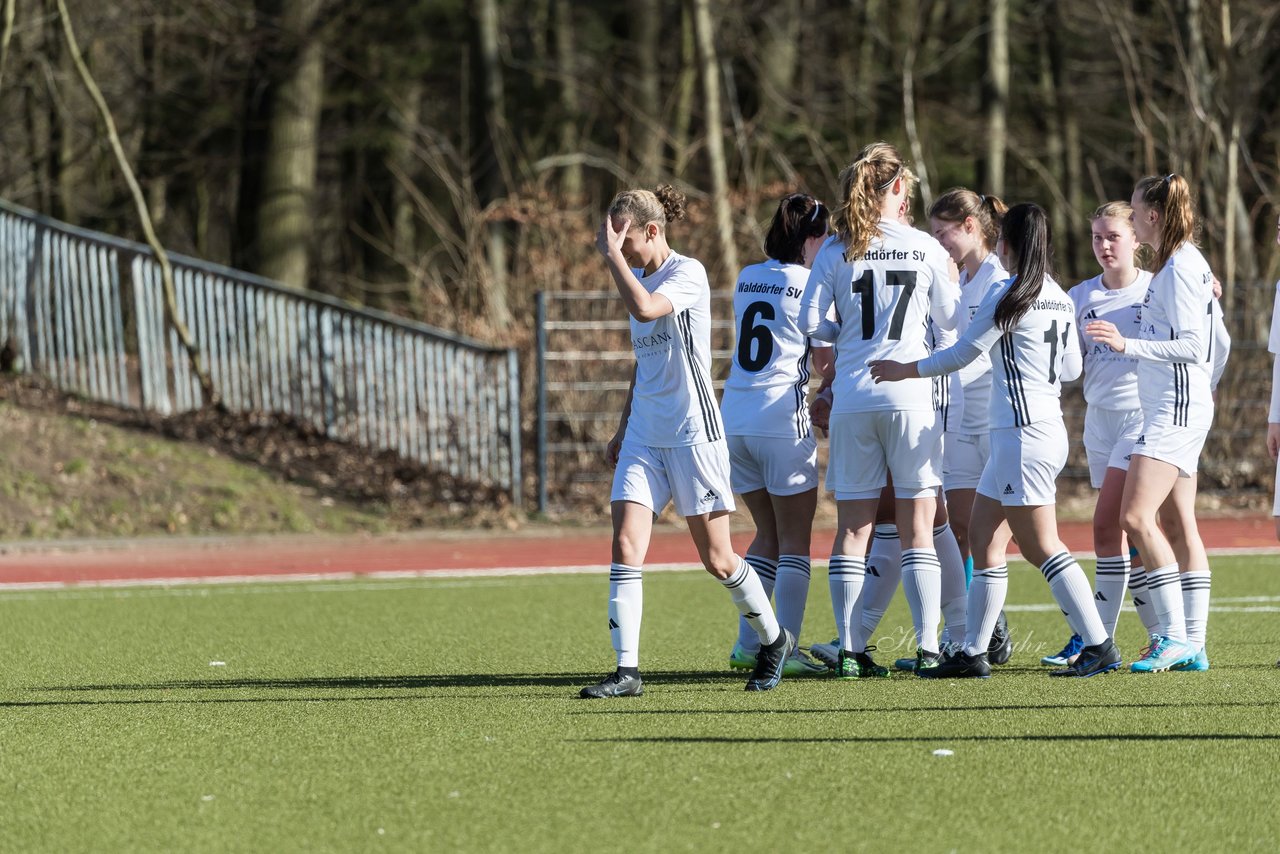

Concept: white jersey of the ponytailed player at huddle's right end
[[1125, 243, 1213, 430]]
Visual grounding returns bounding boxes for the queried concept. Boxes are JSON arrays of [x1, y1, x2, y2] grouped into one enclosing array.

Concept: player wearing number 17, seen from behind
[[800, 142, 959, 679]]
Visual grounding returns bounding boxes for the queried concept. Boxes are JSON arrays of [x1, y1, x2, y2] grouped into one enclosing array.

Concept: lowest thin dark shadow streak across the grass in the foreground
[[568, 732, 1280, 744]]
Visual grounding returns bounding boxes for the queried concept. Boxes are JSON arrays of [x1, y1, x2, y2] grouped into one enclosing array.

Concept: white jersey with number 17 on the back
[[800, 219, 959, 414]]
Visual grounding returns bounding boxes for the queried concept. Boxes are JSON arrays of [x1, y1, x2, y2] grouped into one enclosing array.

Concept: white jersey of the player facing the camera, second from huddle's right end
[[1068, 270, 1152, 411]]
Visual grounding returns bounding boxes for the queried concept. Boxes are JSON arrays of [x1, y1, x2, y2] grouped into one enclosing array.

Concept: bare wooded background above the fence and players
[[0, 0, 1280, 342]]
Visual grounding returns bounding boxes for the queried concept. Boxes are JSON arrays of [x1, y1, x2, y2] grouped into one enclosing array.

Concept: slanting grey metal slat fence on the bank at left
[[0, 201, 521, 504]]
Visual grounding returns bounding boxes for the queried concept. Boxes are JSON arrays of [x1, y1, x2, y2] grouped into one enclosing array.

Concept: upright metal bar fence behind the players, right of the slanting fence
[[536, 283, 1275, 511]]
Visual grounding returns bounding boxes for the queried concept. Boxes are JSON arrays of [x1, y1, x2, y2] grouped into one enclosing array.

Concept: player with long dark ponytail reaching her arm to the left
[[870, 205, 1120, 679]]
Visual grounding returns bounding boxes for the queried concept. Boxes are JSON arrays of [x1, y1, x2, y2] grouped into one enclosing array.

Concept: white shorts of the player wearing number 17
[[827, 410, 942, 501]]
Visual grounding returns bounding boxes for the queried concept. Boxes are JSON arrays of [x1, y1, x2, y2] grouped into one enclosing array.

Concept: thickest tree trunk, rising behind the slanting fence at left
[[257, 0, 324, 288]]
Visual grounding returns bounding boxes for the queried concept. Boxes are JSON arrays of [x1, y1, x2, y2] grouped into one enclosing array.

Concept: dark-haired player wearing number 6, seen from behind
[[721, 193, 833, 676]]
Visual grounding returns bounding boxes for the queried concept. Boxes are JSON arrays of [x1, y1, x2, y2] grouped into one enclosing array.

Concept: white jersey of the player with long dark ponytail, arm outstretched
[[918, 277, 1080, 429]]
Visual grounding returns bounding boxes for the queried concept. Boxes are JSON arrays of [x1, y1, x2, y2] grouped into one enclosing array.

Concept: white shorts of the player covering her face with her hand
[[609, 438, 736, 516]]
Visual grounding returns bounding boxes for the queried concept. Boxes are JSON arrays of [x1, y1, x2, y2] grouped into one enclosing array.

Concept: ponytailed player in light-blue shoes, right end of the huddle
[[1084, 174, 1213, 672]]
